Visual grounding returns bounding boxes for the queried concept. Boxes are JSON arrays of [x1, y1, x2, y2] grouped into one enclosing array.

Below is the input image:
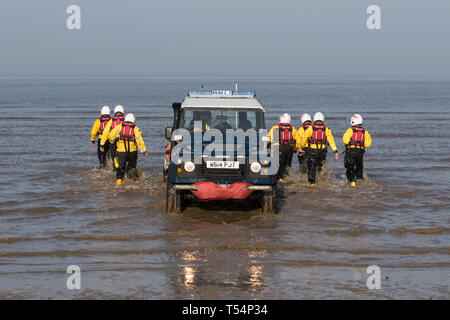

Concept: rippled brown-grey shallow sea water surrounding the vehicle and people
[[0, 78, 450, 299]]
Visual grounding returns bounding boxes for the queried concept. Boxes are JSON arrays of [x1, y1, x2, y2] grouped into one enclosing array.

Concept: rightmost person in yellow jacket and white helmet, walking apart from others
[[342, 114, 372, 187]]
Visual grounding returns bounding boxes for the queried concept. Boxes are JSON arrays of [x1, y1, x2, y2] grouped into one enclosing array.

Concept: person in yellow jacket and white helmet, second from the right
[[301, 112, 339, 187]]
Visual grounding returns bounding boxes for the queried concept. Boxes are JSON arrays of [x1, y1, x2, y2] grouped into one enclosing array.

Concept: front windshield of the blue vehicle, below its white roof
[[180, 108, 265, 132]]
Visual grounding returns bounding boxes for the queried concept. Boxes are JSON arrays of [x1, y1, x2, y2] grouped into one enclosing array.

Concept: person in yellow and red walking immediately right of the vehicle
[[267, 113, 297, 182]]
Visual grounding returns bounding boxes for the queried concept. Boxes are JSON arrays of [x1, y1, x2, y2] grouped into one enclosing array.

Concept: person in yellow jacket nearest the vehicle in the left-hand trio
[[100, 113, 148, 184]]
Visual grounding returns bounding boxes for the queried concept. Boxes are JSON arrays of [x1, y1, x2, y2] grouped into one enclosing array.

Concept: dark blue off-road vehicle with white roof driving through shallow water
[[164, 90, 277, 213]]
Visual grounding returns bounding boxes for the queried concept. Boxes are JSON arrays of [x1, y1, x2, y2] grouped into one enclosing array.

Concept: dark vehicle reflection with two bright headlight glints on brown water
[[167, 201, 280, 299]]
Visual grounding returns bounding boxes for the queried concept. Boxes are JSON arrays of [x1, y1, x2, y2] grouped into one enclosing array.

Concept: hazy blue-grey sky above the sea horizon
[[0, 0, 450, 77]]
